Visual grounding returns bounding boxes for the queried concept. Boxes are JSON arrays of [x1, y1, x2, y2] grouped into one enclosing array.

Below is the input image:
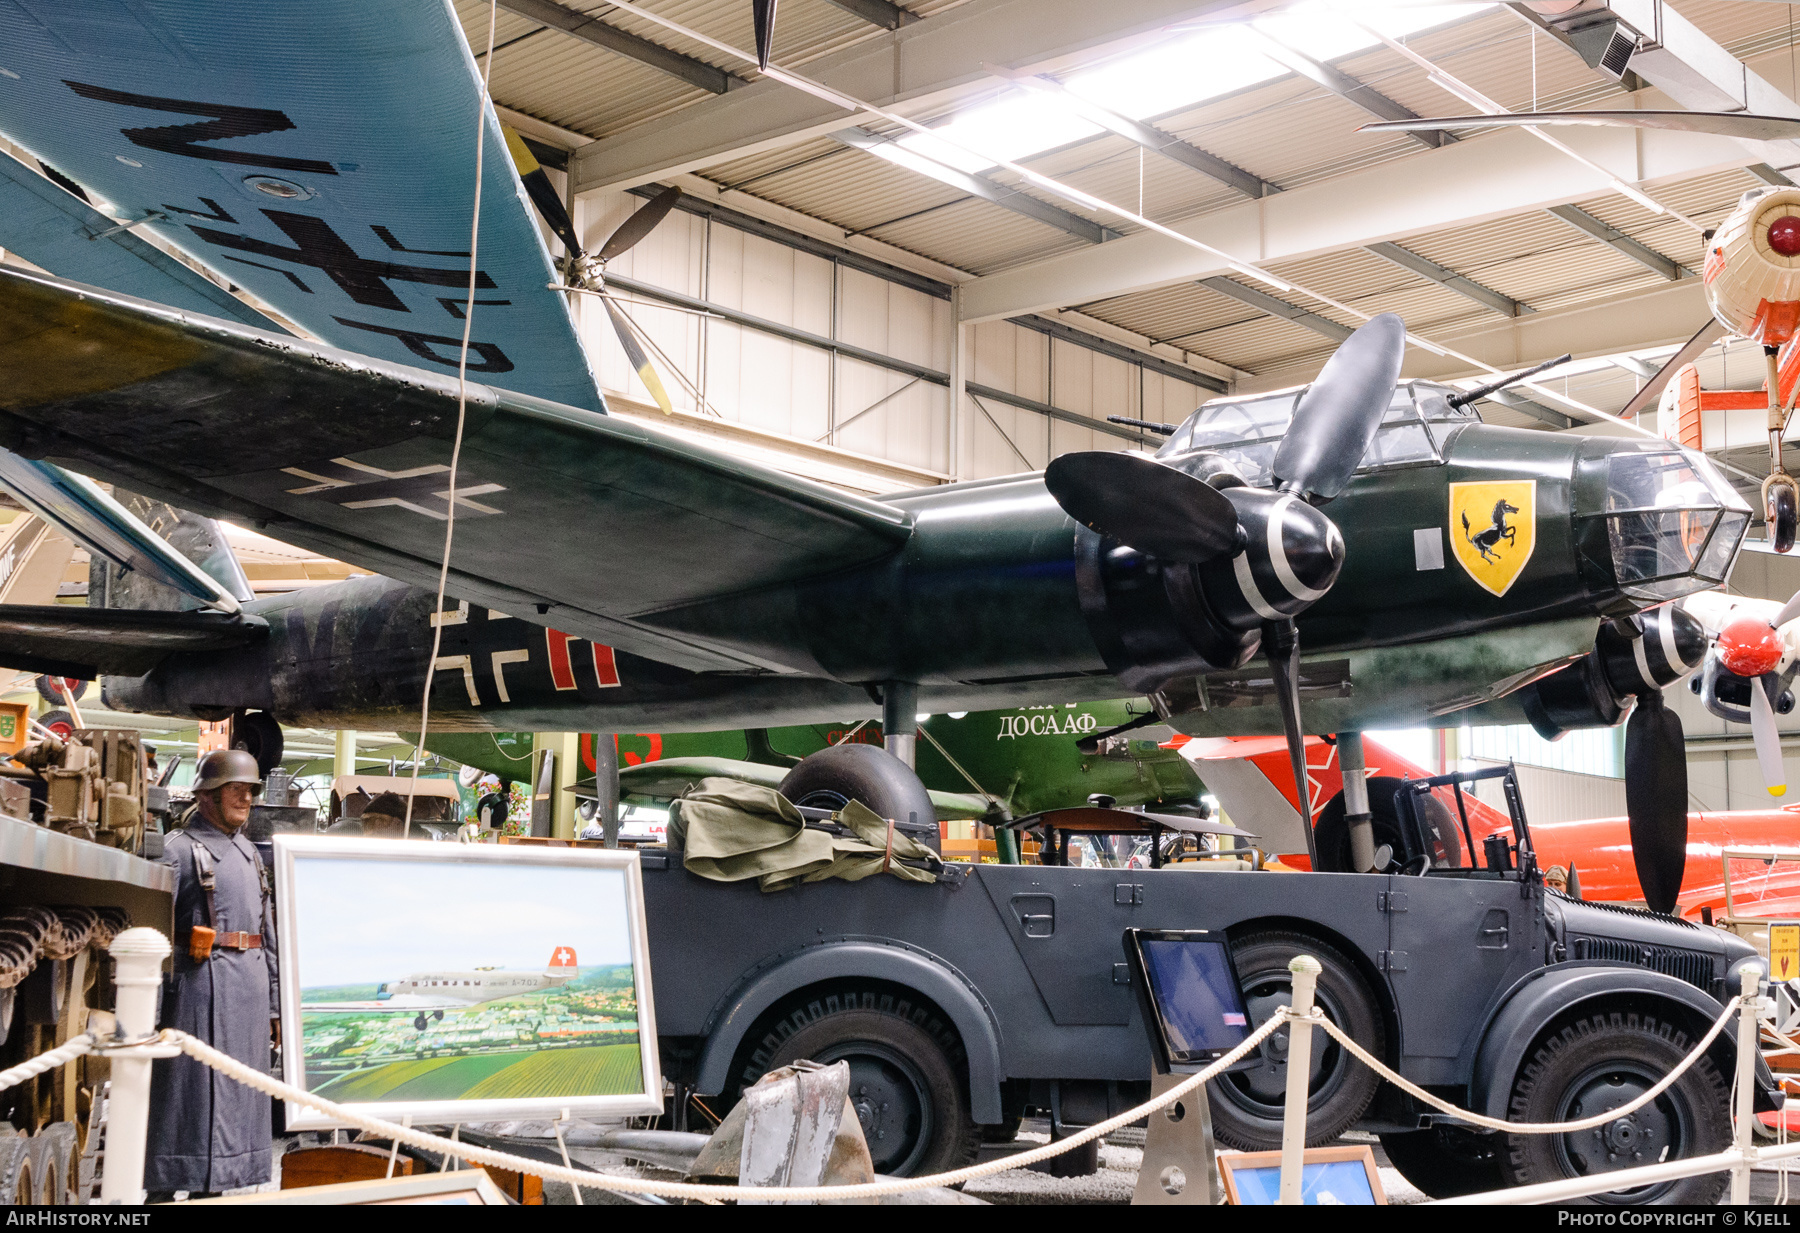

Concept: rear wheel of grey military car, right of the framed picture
[[740, 985, 981, 1177]]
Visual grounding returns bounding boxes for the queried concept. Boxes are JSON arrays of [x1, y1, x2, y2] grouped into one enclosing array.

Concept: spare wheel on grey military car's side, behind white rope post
[[1206, 931, 1388, 1152]]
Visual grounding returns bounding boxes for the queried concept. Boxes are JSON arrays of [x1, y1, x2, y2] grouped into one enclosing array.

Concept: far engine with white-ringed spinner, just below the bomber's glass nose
[[1519, 605, 1706, 740]]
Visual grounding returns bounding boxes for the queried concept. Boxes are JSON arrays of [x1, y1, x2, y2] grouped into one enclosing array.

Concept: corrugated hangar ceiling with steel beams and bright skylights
[[459, 0, 1800, 437]]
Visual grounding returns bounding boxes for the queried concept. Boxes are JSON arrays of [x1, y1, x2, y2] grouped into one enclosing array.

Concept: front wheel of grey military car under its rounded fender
[[1501, 1012, 1732, 1206]]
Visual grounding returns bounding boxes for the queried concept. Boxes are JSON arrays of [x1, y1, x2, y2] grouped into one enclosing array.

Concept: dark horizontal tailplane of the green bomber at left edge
[[0, 603, 268, 680]]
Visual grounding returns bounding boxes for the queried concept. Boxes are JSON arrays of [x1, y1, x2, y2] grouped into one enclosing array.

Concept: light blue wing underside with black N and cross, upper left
[[0, 0, 601, 410]]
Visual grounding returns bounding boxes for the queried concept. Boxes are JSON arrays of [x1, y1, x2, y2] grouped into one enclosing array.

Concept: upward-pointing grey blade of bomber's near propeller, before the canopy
[[1273, 313, 1406, 504]]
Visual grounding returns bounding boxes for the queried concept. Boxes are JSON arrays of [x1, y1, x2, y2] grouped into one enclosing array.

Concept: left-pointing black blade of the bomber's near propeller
[[1044, 450, 1240, 563]]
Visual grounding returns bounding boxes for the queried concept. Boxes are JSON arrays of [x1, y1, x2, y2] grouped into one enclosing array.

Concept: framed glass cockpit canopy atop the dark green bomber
[[1156, 382, 1481, 488]]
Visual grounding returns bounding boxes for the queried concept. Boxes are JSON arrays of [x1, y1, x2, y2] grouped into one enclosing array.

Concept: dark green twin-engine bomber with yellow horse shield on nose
[[0, 272, 1750, 892]]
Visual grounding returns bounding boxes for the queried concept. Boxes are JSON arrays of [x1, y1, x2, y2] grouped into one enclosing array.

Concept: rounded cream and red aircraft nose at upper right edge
[[1703, 187, 1800, 347]]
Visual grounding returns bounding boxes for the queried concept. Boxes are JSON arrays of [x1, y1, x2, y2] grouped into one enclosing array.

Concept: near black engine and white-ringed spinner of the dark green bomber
[[1075, 486, 1345, 693]]
